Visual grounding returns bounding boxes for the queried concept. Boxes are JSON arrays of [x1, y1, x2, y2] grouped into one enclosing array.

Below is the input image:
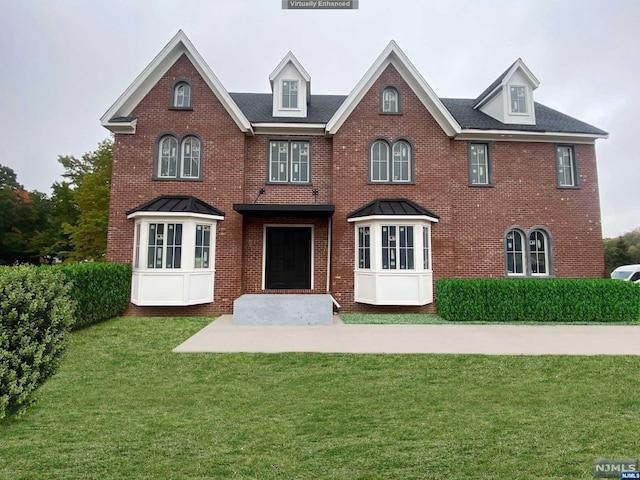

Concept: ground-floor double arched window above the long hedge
[[505, 227, 551, 277]]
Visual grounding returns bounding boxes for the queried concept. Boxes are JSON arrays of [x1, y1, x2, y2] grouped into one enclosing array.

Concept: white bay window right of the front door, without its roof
[[348, 215, 438, 305]]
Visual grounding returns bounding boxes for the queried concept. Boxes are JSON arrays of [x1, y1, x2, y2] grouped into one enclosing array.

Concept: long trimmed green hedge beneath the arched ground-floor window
[[436, 278, 640, 323]]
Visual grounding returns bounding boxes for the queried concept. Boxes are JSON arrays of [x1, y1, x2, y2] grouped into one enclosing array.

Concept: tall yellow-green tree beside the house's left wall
[[58, 140, 113, 261]]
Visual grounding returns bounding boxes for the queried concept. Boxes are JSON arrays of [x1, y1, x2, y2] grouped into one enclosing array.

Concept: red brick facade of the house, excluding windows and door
[[107, 50, 604, 315]]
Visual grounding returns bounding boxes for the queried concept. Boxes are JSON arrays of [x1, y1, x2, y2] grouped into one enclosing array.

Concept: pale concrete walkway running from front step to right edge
[[173, 315, 640, 355]]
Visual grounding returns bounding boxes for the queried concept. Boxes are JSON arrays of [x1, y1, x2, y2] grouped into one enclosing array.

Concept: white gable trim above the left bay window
[[100, 30, 253, 133]]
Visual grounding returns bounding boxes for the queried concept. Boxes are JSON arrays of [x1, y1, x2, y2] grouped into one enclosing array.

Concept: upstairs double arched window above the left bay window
[[156, 135, 202, 180]]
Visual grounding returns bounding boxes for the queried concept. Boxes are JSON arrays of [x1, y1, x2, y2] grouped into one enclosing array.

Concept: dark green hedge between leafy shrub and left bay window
[[54, 262, 131, 328]]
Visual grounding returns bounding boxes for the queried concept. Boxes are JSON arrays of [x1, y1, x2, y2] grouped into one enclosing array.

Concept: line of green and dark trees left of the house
[[0, 140, 113, 265]]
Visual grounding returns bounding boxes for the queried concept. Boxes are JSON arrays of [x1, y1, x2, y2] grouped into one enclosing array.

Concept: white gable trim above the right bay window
[[327, 40, 460, 137]]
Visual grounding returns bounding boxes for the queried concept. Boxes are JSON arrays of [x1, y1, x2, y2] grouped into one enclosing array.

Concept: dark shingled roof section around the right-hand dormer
[[440, 98, 607, 135]]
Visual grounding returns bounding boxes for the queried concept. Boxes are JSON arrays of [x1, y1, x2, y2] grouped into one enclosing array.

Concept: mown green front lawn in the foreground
[[0, 318, 640, 480]]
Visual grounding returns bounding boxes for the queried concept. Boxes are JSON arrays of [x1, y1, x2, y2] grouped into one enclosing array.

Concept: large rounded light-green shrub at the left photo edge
[[0, 266, 74, 418]]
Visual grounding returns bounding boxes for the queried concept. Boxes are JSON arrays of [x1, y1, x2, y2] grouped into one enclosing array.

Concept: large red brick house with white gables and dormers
[[101, 31, 607, 315]]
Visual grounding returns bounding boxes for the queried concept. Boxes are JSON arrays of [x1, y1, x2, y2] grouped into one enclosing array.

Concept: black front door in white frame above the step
[[265, 227, 311, 289]]
